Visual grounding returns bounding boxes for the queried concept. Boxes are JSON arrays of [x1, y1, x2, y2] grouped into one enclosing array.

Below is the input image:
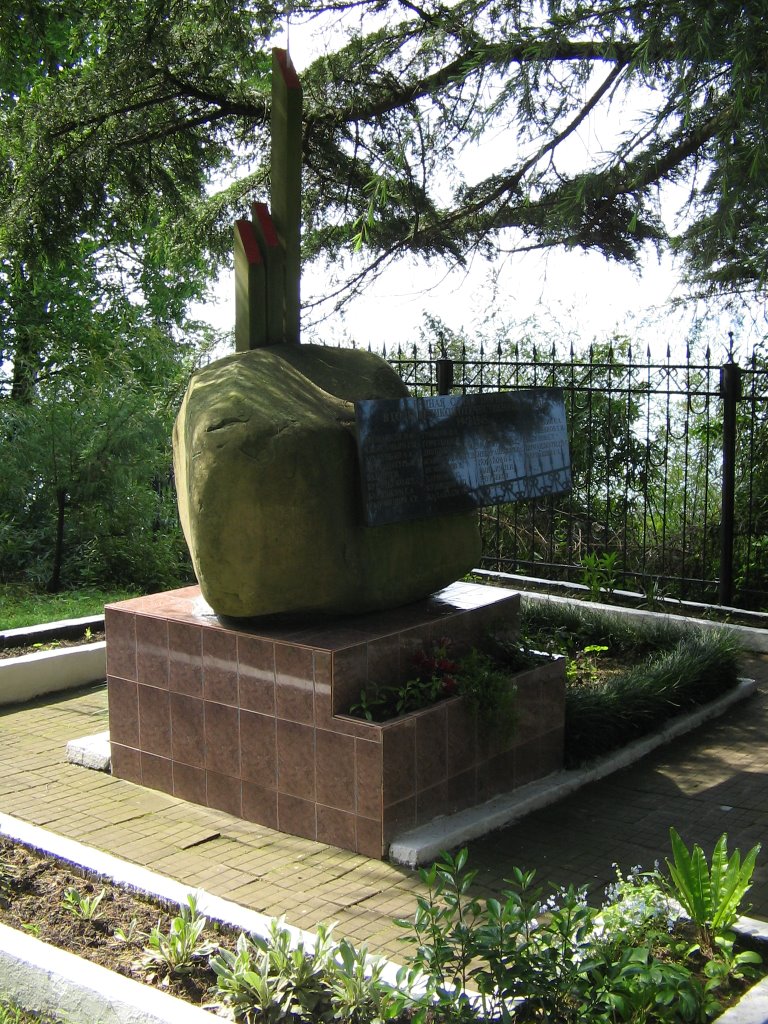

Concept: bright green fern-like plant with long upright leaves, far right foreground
[[667, 828, 760, 956]]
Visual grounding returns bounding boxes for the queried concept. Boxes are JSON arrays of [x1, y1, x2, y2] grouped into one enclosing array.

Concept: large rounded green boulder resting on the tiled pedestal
[[173, 344, 480, 617]]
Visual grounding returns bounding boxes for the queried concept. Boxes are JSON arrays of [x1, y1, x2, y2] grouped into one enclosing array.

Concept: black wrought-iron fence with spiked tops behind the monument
[[383, 337, 768, 609]]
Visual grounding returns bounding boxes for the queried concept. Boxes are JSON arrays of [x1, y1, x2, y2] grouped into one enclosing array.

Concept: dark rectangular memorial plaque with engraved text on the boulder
[[354, 388, 570, 526]]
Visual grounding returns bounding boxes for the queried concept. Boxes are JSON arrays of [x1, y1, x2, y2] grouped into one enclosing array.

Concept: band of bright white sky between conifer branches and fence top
[[196, 211, 766, 360]]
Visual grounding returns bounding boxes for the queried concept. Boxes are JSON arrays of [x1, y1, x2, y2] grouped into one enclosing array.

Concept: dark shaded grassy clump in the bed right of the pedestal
[[522, 603, 742, 768]]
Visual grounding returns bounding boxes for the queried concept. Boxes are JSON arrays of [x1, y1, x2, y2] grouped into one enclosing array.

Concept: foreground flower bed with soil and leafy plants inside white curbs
[[0, 830, 762, 1024]]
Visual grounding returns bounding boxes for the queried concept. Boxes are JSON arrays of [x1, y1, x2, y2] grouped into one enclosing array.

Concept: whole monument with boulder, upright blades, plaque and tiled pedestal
[[105, 50, 569, 857]]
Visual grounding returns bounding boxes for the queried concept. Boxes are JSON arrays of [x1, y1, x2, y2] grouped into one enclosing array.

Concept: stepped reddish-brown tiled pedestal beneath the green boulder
[[106, 584, 564, 857]]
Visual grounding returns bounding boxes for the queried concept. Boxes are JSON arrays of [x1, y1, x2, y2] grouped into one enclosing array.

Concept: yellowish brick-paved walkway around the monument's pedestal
[[0, 658, 768, 958]]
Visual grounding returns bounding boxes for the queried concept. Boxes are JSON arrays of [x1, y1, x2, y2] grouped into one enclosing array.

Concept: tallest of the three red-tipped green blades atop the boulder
[[271, 48, 302, 343]]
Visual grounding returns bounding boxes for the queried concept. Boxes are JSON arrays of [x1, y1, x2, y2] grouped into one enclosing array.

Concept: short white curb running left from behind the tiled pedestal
[[0, 640, 106, 705]]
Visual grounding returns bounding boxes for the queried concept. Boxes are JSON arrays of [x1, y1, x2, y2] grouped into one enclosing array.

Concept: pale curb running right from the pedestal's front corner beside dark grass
[[389, 679, 757, 867]]
